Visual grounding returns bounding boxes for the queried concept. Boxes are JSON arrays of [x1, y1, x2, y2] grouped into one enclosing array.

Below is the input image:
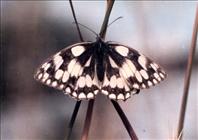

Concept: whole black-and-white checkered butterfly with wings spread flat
[[34, 37, 167, 101]]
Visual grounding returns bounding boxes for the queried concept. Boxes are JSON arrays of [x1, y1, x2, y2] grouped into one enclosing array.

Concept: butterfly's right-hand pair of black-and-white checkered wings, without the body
[[102, 43, 166, 100]]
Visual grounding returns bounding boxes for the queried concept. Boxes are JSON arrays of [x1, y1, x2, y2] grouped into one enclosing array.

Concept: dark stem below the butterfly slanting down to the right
[[111, 100, 138, 140]]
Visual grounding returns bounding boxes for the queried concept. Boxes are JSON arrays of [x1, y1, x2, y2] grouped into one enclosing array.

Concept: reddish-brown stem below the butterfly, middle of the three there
[[81, 99, 94, 140]]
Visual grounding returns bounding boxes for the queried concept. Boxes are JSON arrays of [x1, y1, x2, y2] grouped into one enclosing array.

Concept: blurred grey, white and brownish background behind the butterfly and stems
[[1, 1, 198, 140]]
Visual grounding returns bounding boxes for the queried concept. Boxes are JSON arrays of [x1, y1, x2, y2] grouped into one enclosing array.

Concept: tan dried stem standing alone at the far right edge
[[177, 5, 198, 139]]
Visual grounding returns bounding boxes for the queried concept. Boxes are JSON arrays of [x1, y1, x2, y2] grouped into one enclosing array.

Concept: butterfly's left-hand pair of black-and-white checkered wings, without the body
[[35, 42, 98, 100]]
